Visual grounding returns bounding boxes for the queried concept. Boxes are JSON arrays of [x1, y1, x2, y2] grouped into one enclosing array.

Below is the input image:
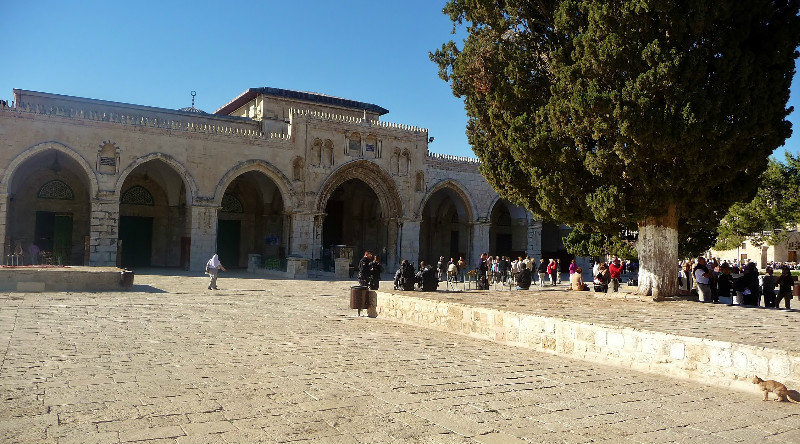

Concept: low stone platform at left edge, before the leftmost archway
[[0, 267, 133, 292]]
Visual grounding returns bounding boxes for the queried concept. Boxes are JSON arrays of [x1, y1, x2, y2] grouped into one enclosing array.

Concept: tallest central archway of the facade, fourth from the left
[[322, 179, 389, 262]]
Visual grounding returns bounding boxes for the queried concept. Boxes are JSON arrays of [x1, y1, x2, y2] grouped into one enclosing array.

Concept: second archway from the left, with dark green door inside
[[117, 159, 190, 268]]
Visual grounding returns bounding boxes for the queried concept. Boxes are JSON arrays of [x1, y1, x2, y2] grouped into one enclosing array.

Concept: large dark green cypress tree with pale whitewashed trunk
[[431, 0, 800, 298]]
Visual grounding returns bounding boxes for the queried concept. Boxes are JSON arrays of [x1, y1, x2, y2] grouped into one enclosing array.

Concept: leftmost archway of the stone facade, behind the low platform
[[5, 149, 91, 265]]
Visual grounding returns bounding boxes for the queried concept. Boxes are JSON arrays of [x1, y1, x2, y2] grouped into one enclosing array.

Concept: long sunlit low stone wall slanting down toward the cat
[[378, 292, 800, 392]]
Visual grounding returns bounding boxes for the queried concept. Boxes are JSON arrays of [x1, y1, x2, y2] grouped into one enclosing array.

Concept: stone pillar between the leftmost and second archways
[[89, 195, 119, 267]]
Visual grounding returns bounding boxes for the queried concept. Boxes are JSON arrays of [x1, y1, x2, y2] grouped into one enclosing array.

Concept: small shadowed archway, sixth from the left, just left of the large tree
[[489, 199, 528, 258]]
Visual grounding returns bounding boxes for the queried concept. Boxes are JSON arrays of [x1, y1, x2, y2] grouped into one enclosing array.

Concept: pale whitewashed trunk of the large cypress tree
[[636, 205, 678, 301]]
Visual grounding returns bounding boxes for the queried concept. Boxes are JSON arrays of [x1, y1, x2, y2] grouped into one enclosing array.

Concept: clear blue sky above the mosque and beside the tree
[[0, 0, 800, 156]]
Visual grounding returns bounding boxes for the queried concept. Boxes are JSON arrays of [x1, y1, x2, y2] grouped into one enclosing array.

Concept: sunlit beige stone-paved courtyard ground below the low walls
[[0, 273, 800, 443]]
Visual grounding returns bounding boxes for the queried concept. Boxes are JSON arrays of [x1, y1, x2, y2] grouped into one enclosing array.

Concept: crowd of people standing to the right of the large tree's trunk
[[678, 256, 795, 309]]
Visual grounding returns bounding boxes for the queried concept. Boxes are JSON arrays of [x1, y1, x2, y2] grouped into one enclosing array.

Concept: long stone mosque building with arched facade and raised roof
[[0, 88, 565, 271]]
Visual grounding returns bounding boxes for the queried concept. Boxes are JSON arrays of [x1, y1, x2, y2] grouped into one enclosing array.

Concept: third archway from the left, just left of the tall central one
[[217, 170, 287, 267]]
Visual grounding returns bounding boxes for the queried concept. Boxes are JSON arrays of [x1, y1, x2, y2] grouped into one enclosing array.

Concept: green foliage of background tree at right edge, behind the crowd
[[714, 153, 800, 250]]
